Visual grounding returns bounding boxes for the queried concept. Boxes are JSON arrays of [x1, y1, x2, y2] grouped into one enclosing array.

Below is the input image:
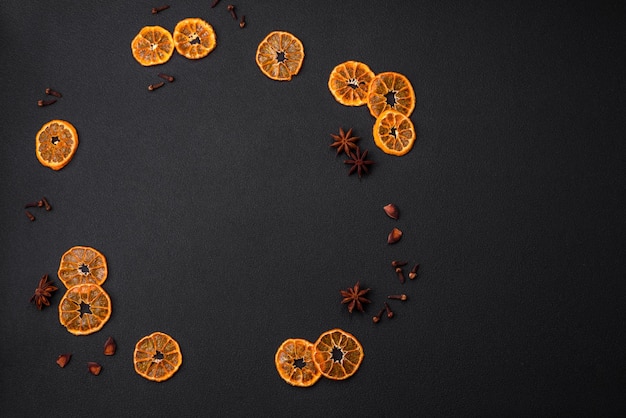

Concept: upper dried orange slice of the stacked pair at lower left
[[57, 246, 108, 288]]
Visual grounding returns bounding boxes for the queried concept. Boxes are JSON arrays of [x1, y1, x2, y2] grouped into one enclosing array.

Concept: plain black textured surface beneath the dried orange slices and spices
[[0, 0, 626, 416]]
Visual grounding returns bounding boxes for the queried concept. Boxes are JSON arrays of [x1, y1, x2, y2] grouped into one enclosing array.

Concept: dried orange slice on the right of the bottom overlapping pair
[[313, 328, 363, 380]]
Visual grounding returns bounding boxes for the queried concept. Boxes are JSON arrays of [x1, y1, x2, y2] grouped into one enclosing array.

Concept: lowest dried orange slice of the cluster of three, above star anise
[[373, 109, 416, 156]]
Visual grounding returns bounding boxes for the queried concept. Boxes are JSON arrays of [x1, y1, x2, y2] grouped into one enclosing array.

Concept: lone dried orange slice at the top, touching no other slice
[[256, 31, 304, 81]]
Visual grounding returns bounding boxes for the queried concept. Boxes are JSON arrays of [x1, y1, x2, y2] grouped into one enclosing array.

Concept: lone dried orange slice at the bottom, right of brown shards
[[133, 332, 183, 382]]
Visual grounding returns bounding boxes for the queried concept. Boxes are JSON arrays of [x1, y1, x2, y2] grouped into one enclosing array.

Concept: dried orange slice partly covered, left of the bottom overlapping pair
[[274, 338, 322, 387]]
